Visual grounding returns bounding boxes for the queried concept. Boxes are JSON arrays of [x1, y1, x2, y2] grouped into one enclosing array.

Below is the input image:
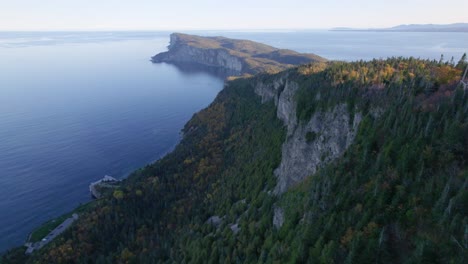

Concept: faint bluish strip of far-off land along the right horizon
[[331, 23, 468, 32]]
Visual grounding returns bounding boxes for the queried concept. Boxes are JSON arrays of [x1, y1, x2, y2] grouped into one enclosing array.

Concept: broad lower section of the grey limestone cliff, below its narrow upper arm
[[275, 104, 362, 194]]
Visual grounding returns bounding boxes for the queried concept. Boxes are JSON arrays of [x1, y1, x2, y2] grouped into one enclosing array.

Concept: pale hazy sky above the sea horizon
[[0, 0, 468, 30]]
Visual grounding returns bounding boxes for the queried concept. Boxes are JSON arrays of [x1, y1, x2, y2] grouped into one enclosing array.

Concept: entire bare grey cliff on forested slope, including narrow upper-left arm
[[255, 75, 362, 194]]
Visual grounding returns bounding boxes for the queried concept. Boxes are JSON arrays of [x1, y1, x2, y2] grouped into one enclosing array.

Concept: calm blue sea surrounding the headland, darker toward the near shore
[[0, 31, 468, 252]]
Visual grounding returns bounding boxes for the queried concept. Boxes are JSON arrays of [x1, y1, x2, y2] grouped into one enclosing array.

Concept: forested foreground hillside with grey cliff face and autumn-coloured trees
[[1, 58, 468, 263]]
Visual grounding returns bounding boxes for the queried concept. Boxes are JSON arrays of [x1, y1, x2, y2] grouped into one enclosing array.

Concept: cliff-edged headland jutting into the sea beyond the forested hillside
[[152, 33, 326, 77]]
